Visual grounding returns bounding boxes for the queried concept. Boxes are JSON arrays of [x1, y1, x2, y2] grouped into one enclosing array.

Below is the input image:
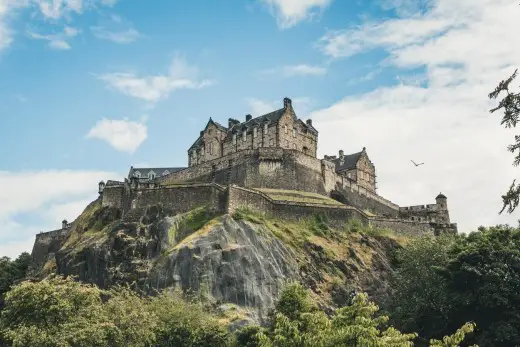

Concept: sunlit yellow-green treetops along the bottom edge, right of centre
[[255, 284, 473, 347]]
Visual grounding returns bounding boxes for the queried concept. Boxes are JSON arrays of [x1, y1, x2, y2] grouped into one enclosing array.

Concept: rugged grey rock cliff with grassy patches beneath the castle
[[33, 199, 406, 321]]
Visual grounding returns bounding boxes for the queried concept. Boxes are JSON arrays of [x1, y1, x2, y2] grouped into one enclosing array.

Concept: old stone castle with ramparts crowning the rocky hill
[[31, 98, 457, 270]]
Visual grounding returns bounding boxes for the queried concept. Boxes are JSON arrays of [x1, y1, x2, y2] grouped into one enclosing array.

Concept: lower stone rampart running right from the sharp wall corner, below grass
[[227, 186, 368, 227]]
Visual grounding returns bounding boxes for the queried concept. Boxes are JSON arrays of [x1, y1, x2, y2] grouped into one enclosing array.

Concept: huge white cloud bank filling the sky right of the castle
[[312, 0, 520, 231]]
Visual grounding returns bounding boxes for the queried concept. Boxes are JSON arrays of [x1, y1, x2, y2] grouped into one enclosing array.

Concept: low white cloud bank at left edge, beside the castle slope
[[0, 170, 122, 258]]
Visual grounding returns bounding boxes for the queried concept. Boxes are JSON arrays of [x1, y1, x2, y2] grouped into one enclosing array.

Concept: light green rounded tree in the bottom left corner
[[0, 277, 157, 347]]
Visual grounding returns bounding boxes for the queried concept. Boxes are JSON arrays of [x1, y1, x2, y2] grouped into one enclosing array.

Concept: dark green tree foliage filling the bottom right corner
[[385, 226, 520, 347]]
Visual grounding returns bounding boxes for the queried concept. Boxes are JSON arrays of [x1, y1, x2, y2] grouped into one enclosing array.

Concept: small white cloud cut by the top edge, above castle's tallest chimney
[[262, 0, 332, 29]]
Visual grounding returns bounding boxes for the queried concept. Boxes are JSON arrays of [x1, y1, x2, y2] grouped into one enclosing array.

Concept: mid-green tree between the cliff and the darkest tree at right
[[384, 234, 458, 345]]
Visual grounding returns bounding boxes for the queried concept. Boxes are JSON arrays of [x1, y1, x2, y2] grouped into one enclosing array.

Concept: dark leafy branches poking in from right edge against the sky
[[488, 70, 520, 213]]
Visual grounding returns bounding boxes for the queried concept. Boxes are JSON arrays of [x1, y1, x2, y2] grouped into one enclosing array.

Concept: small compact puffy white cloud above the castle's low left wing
[[87, 118, 148, 153]]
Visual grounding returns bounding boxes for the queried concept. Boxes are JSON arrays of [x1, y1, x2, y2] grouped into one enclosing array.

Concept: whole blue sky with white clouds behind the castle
[[0, 0, 520, 257]]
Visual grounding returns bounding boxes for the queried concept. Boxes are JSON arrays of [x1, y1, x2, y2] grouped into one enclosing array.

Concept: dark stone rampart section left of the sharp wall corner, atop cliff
[[131, 183, 226, 214]]
